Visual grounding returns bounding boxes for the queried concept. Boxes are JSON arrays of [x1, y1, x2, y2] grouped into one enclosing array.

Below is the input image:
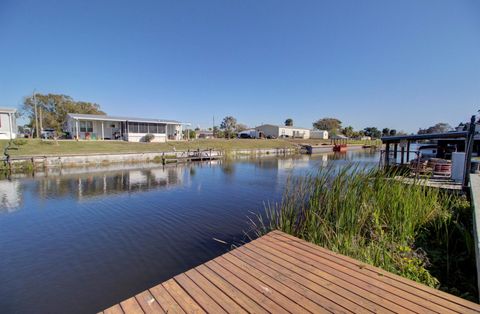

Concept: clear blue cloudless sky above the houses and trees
[[0, 0, 480, 132]]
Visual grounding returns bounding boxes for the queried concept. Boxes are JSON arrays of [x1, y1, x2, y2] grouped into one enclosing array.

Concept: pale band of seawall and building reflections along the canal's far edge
[[0, 151, 376, 214]]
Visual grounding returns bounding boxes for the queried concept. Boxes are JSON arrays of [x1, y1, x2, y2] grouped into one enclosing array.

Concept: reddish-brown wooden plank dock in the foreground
[[104, 231, 480, 313]]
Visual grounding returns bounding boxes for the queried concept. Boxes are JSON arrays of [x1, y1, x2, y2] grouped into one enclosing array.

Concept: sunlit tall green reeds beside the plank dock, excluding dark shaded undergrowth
[[251, 164, 454, 287]]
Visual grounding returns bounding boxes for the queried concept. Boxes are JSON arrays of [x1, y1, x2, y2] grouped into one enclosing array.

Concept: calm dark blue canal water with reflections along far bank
[[0, 151, 379, 313]]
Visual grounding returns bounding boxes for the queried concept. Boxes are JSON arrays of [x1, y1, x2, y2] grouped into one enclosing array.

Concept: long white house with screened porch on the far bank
[[64, 113, 188, 142]]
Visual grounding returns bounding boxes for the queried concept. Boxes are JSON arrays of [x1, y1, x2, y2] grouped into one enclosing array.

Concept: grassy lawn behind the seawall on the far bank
[[0, 139, 295, 156]]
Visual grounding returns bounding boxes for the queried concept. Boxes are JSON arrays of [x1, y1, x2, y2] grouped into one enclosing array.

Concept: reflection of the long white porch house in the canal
[[37, 167, 182, 199]]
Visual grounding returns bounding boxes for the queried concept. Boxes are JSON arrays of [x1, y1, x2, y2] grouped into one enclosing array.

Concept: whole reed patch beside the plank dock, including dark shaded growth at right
[[251, 165, 478, 301]]
